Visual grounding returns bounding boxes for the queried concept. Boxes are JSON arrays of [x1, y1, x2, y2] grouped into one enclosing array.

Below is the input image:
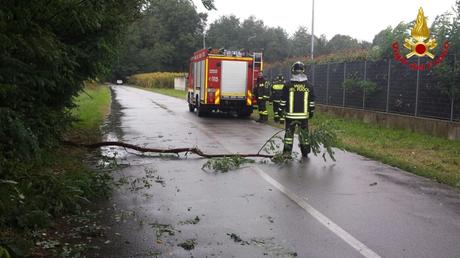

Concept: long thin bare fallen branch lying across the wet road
[[62, 141, 273, 158]]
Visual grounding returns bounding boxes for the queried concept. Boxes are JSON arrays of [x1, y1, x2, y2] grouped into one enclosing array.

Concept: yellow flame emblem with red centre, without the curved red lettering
[[404, 7, 437, 59]]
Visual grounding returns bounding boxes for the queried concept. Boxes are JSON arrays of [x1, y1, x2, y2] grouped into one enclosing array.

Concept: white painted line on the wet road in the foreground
[[251, 167, 381, 258]]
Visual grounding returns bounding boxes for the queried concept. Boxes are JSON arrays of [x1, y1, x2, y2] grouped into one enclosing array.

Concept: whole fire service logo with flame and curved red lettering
[[392, 7, 449, 71]]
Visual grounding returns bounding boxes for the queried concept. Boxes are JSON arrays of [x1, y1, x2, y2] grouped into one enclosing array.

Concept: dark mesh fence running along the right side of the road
[[265, 56, 460, 121]]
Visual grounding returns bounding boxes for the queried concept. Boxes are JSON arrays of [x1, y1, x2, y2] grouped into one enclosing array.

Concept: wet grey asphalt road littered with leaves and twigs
[[98, 86, 460, 257]]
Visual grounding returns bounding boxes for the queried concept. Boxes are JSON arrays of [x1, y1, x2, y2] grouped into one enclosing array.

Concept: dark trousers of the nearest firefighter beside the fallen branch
[[283, 118, 310, 156]]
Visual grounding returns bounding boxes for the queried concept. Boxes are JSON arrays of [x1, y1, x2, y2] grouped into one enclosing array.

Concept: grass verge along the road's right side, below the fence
[[141, 88, 460, 188]]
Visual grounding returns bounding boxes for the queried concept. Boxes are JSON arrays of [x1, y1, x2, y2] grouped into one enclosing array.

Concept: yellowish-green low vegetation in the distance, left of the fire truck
[[128, 72, 184, 89]]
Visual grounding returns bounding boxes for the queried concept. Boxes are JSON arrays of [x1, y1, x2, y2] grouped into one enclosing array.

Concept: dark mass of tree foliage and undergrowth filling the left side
[[0, 0, 138, 234]]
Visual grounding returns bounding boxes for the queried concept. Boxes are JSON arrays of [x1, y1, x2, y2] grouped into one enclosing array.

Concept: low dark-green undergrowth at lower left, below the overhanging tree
[[0, 148, 110, 229]]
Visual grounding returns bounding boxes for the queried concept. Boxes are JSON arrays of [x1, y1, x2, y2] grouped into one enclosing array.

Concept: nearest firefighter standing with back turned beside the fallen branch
[[281, 62, 315, 157]]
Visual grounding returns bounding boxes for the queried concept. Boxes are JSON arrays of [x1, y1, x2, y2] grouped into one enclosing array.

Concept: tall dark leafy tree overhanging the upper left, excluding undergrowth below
[[0, 0, 144, 165]]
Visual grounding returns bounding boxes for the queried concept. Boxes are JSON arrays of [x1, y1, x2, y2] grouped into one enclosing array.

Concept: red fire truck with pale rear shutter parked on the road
[[187, 49, 263, 116]]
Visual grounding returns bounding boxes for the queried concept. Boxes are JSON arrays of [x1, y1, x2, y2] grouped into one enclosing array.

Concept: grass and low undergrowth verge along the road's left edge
[[0, 85, 111, 257]]
